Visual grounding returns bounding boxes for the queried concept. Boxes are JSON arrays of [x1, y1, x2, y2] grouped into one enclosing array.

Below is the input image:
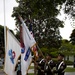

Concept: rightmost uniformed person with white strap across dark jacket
[[54, 53, 66, 75]]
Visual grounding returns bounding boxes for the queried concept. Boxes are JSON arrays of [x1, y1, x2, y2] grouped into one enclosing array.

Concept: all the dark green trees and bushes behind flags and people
[[0, 0, 75, 63]]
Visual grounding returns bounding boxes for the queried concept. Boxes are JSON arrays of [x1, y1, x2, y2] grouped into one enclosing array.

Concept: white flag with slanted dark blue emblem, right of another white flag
[[21, 15, 36, 75]]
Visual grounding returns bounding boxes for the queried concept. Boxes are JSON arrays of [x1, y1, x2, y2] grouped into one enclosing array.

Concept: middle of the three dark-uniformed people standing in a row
[[44, 54, 55, 75]]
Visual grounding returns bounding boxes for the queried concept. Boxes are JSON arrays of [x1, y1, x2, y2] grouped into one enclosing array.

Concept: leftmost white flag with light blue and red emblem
[[4, 29, 21, 75]]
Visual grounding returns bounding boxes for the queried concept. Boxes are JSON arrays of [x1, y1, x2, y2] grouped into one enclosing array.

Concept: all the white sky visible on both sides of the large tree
[[0, 0, 73, 40]]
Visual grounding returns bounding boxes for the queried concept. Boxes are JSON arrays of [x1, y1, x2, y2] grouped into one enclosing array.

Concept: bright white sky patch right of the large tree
[[57, 5, 74, 40]]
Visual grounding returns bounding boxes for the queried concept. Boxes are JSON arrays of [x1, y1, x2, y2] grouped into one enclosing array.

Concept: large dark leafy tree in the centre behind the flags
[[12, 0, 66, 48]]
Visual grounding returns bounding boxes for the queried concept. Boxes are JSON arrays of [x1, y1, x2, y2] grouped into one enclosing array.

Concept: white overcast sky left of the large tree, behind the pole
[[0, 0, 18, 30]]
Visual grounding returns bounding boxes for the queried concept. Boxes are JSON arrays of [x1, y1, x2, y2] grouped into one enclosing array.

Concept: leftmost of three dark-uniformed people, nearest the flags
[[37, 54, 45, 75]]
